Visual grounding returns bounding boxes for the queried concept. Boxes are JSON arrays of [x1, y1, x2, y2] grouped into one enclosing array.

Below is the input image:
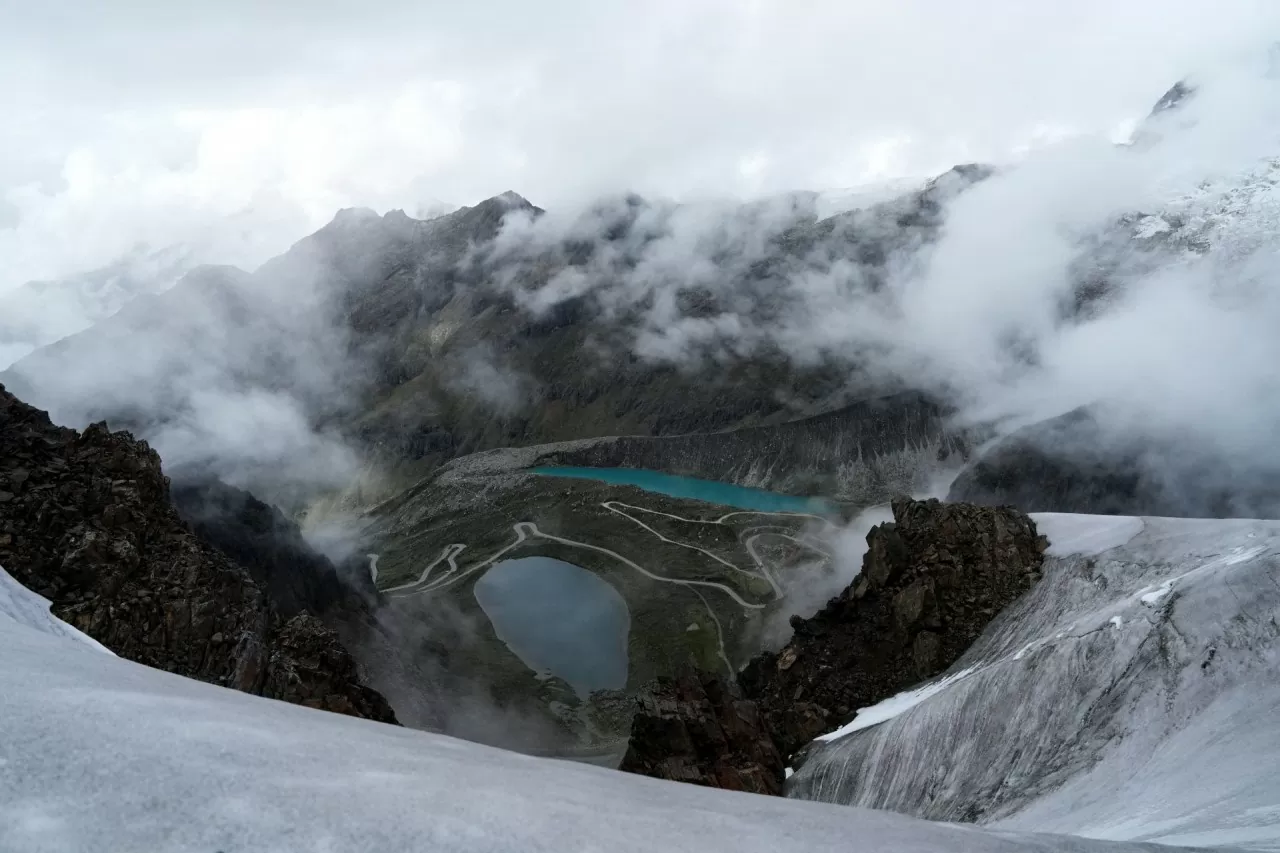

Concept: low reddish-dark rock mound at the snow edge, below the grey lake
[[620, 671, 785, 795]]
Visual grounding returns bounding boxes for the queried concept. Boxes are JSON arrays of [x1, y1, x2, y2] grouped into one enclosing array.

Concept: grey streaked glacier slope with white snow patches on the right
[[787, 515, 1280, 850]]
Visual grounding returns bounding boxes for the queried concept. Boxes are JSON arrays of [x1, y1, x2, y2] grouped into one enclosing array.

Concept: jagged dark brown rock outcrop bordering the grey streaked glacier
[[740, 498, 1047, 756]]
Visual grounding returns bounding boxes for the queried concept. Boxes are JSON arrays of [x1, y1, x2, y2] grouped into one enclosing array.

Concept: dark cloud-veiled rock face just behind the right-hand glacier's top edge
[[947, 407, 1280, 519]]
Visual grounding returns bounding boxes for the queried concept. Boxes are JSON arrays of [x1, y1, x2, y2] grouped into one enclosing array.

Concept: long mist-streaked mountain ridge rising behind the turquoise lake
[[3, 167, 989, 492]]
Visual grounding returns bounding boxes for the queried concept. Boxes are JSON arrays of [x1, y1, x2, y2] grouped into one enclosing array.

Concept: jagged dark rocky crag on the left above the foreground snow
[[0, 387, 394, 722]]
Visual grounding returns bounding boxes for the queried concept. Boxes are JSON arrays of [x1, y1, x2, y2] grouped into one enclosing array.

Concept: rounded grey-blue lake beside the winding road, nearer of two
[[475, 557, 631, 697]]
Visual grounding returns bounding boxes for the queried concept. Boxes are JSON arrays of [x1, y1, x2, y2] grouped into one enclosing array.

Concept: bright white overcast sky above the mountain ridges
[[0, 0, 1280, 291]]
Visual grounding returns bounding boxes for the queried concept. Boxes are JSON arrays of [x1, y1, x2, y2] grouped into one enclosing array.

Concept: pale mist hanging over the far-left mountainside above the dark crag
[[0, 227, 366, 511]]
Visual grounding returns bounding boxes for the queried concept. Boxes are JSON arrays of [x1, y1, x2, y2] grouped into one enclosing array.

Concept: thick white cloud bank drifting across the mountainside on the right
[[473, 50, 1280, 522]]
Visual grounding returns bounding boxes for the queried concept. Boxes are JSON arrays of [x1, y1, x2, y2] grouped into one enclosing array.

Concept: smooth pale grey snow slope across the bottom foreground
[[0, 563, 1198, 853]]
